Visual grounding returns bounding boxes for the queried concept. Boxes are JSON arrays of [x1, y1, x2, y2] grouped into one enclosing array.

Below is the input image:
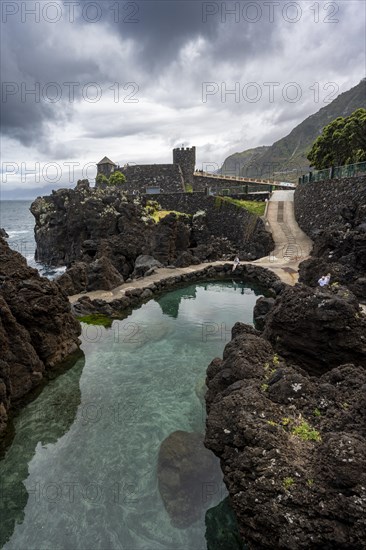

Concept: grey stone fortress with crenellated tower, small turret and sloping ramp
[[97, 147, 294, 194]]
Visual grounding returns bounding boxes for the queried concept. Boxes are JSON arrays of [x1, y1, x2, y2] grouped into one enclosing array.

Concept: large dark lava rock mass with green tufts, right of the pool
[[205, 285, 366, 550]]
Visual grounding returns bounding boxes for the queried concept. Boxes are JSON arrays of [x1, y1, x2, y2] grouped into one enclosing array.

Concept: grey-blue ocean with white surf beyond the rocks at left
[[0, 201, 65, 279]]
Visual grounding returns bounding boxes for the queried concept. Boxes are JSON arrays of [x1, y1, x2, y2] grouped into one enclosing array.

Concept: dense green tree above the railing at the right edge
[[307, 109, 366, 170]]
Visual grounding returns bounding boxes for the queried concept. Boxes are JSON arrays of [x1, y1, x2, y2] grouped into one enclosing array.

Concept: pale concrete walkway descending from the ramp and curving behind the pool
[[70, 191, 312, 303]]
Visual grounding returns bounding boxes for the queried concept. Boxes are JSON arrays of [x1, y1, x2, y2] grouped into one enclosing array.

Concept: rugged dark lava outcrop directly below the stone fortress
[[31, 185, 273, 294]]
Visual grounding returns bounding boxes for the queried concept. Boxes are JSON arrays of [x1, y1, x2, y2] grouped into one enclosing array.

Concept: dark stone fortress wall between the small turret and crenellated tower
[[120, 164, 184, 193]]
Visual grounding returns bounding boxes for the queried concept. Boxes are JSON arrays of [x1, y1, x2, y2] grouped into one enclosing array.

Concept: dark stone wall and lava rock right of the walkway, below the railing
[[295, 176, 366, 300]]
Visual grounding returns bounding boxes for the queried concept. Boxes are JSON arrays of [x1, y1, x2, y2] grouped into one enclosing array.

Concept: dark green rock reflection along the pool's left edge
[[0, 357, 85, 546]]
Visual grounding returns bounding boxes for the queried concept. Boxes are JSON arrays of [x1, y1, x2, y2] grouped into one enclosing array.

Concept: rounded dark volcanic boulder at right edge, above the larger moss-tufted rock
[[263, 284, 366, 375]]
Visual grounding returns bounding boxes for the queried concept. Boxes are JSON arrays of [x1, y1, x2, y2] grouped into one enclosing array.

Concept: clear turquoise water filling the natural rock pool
[[0, 282, 260, 550]]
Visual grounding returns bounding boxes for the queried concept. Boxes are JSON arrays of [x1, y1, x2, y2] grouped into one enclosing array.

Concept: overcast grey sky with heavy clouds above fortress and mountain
[[1, 0, 366, 198]]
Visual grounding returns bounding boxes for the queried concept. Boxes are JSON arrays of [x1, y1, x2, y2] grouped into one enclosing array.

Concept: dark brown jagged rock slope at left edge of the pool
[[0, 237, 81, 442]]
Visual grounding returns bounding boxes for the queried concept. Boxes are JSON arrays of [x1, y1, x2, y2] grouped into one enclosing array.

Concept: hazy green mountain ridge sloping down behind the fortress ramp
[[219, 78, 366, 182]]
